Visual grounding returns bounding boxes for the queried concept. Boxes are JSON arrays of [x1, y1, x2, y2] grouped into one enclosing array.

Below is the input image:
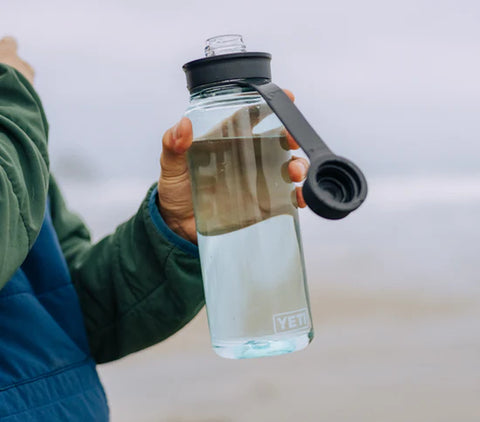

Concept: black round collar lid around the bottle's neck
[[183, 53, 272, 92]]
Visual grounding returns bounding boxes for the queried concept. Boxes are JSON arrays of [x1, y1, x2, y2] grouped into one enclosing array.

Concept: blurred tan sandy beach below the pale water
[[100, 289, 480, 422]]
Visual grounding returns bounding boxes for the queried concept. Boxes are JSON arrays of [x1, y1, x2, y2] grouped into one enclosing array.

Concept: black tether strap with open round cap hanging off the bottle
[[240, 79, 368, 220]]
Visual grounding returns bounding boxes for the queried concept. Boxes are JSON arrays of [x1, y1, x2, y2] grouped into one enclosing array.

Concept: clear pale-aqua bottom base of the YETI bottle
[[212, 330, 313, 359]]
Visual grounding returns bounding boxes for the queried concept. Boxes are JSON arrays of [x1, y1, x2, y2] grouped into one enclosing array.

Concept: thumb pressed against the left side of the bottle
[[160, 117, 193, 177]]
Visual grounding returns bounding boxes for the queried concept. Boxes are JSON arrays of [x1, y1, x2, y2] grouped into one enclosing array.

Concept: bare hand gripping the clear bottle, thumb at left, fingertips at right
[[158, 91, 309, 243]]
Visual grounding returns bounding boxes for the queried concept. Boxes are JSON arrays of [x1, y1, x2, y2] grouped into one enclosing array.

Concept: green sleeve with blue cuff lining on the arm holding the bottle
[[50, 178, 204, 363]]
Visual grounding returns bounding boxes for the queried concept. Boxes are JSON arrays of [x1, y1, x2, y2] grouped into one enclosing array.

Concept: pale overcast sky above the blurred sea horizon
[[0, 0, 480, 178]]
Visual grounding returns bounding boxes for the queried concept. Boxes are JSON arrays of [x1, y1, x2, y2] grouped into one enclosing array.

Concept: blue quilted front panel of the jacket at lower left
[[0, 210, 108, 422]]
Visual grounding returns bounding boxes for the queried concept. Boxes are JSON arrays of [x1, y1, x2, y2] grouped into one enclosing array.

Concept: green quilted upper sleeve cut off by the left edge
[[0, 64, 49, 289]]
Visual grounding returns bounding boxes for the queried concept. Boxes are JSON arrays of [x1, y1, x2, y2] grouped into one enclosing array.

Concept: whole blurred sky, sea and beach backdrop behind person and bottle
[[0, 0, 480, 422]]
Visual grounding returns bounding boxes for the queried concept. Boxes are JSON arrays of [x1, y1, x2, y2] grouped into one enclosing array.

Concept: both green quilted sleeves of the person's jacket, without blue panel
[[0, 65, 204, 363]]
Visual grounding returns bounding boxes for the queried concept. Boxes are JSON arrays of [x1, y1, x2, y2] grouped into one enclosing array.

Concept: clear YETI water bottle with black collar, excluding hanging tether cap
[[184, 36, 368, 359]]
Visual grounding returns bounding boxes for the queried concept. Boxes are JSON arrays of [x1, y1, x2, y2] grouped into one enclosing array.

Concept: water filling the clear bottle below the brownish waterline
[[188, 136, 313, 358]]
